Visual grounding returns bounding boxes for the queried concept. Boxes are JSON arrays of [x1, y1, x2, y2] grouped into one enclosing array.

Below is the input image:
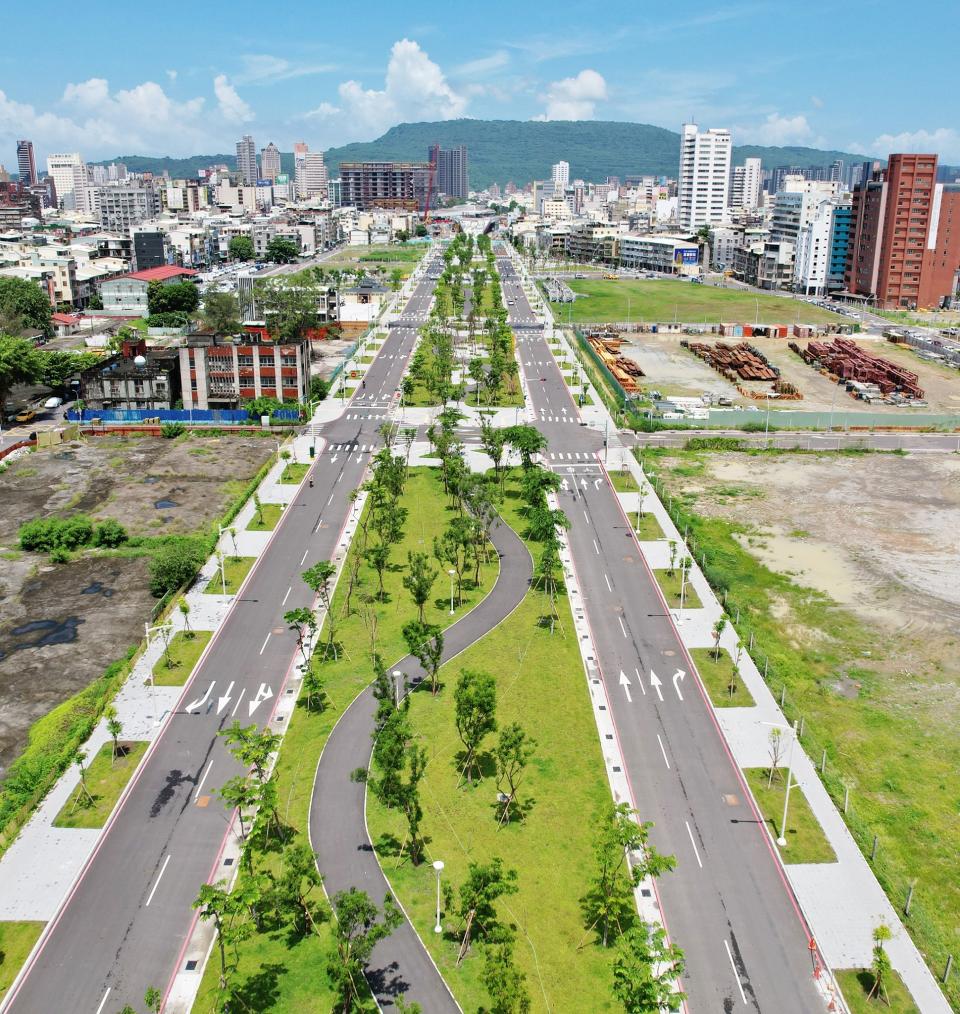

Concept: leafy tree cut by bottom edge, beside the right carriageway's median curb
[[613, 923, 684, 1014]]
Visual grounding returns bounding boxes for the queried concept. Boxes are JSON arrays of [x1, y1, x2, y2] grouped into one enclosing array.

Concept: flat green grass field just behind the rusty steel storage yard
[[557, 278, 844, 323]]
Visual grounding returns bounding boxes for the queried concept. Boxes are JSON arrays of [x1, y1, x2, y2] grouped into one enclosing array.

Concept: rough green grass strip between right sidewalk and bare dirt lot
[[640, 449, 960, 1010]]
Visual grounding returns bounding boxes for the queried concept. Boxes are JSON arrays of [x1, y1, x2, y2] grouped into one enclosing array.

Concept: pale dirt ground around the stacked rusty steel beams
[[621, 334, 960, 418]]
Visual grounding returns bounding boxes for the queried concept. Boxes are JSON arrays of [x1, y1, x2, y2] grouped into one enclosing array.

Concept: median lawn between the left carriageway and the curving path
[[194, 468, 499, 1014]]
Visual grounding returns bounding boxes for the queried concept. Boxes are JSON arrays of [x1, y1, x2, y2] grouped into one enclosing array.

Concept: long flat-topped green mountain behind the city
[[95, 120, 879, 190]]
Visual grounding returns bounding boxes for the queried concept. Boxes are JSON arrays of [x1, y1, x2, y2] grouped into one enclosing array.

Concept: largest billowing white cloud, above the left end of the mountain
[[304, 39, 467, 142]]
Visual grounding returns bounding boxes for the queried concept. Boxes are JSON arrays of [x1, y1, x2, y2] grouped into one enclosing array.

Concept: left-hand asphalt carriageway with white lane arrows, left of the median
[[3, 263, 433, 1014]]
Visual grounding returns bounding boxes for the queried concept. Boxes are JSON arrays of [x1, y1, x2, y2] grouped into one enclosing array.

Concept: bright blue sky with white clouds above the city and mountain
[[0, 0, 960, 169]]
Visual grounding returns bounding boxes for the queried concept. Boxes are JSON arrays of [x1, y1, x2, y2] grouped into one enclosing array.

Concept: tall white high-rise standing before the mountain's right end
[[677, 124, 732, 231]]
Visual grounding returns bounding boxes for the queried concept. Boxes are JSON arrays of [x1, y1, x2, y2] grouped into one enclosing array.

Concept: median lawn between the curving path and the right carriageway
[[367, 474, 618, 1012]]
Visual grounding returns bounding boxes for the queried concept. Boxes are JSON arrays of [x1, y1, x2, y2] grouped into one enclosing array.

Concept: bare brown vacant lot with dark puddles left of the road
[[0, 436, 276, 775]]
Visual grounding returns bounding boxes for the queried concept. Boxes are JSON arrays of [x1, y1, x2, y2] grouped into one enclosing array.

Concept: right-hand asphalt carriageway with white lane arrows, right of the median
[[498, 257, 824, 1014]]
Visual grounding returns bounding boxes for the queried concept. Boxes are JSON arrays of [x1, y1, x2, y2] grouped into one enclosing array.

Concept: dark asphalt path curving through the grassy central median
[[309, 511, 533, 1014]]
